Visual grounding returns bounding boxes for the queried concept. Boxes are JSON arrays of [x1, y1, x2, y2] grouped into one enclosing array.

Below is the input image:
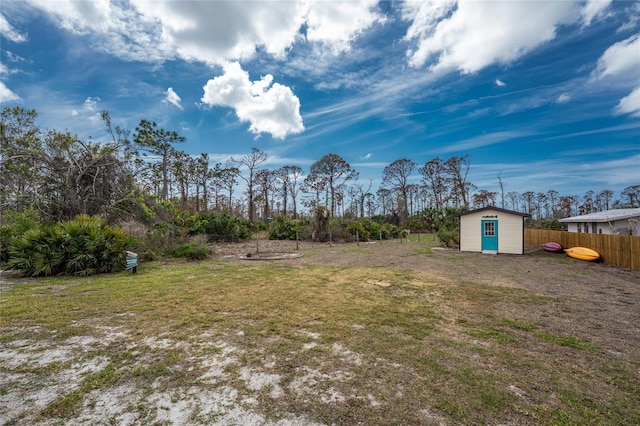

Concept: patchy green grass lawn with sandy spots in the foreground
[[0, 240, 640, 425]]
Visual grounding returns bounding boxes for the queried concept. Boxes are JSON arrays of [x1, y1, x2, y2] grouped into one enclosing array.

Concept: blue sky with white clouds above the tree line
[[0, 0, 640, 198]]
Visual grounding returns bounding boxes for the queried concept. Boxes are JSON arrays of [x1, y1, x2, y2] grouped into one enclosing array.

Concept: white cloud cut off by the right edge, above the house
[[594, 34, 640, 81]]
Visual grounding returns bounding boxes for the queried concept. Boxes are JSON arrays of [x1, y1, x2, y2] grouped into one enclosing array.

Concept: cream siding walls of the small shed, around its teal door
[[460, 209, 524, 254]]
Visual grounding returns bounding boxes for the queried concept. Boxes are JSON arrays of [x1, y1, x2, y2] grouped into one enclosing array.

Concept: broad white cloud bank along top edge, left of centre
[[22, 0, 385, 64]]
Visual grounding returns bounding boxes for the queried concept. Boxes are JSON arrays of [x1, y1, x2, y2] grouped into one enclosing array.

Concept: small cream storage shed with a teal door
[[457, 207, 531, 254]]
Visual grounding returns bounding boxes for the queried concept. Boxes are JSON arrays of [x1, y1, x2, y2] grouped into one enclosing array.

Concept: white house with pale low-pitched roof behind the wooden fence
[[559, 208, 640, 235]]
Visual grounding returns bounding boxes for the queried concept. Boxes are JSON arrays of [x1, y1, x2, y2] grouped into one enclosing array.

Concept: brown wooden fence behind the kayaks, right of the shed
[[524, 228, 640, 271]]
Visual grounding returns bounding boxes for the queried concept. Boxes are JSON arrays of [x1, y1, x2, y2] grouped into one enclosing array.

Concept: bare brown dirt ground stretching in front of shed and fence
[[214, 236, 640, 355]]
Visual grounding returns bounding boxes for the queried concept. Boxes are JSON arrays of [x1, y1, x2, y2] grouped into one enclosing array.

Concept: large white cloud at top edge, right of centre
[[403, 1, 578, 73]]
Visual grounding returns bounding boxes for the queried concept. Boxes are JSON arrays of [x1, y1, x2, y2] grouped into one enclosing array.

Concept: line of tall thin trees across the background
[[0, 107, 640, 225]]
